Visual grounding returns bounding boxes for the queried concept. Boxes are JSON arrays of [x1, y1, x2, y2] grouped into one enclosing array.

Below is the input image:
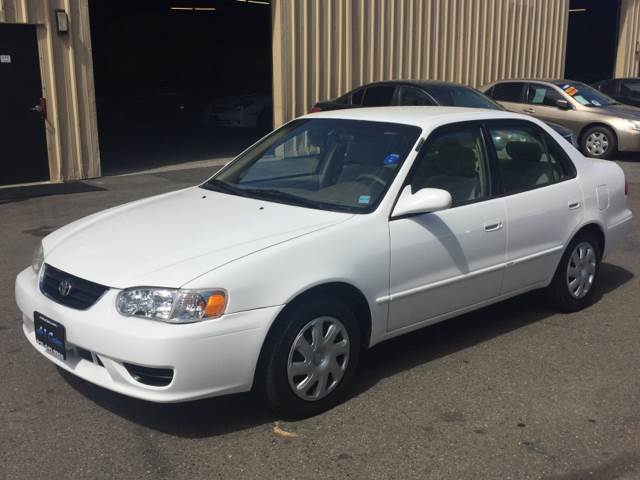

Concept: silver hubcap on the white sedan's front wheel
[[287, 317, 350, 402]]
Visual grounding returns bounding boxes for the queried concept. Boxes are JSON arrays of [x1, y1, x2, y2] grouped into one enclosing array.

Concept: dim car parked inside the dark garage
[[204, 93, 273, 130]]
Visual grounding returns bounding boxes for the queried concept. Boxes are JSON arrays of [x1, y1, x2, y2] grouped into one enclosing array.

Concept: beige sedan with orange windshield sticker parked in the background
[[481, 80, 640, 158]]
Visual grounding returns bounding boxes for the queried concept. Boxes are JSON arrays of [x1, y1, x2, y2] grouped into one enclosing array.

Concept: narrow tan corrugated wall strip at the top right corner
[[615, 0, 640, 77]]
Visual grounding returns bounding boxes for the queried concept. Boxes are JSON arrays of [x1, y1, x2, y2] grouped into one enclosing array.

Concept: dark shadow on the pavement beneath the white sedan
[[59, 263, 633, 438]]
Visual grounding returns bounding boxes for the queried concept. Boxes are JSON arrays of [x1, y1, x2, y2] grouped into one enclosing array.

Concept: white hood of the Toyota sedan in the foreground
[[43, 187, 353, 288]]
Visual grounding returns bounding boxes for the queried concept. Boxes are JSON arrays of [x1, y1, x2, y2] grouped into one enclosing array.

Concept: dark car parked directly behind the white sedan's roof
[[309, 80, 578, 148]]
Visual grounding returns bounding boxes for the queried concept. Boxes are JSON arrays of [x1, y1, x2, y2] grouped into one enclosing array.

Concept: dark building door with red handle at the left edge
[[0, 23, 49, 185]]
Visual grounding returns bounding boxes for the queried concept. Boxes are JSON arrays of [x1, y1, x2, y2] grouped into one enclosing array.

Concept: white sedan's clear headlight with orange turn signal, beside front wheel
[[116, 287, 227, 323]]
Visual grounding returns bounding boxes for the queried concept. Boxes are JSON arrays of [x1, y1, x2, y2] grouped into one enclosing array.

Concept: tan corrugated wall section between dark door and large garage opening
[[0, 0, 100, 181]]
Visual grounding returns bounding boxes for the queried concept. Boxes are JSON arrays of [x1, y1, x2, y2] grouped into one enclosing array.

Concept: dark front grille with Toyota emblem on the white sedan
[[40, 264, 109, 310]]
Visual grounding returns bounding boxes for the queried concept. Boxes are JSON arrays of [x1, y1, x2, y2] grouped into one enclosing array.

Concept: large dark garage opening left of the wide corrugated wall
[[89, 0, 273, 174]]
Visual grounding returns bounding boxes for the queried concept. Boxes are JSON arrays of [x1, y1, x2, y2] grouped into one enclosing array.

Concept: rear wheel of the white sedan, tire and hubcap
[[547, 232, 602, 313]]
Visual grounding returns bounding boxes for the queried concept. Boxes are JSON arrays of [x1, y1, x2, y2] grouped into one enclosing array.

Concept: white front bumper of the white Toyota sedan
[[15, 268, 282, 402]]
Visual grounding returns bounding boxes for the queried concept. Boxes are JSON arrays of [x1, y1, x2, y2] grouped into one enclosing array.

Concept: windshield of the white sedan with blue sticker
[[202, 119, 421, 213]]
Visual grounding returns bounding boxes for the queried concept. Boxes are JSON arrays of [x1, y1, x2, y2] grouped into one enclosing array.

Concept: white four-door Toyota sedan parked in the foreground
[[15, 107, 632, 416]]
